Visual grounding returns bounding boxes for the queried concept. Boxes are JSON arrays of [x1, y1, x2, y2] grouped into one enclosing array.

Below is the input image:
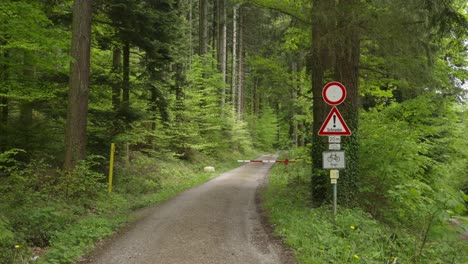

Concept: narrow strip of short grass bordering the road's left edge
[[39, 154, 252, 263]]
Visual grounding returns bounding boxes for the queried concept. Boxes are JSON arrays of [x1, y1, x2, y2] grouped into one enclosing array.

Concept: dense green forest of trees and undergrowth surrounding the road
[[0, 0, 468, 263]]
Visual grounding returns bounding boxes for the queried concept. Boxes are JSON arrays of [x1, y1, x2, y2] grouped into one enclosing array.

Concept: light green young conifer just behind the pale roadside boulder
[[168, 55, 227, 157]]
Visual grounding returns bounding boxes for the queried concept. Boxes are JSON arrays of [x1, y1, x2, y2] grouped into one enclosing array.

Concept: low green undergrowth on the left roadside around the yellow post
[[0, 152, 258, 264]]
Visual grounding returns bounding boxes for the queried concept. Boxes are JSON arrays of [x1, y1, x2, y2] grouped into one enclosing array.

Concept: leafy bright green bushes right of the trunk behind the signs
[[360, 96, 467, 226]]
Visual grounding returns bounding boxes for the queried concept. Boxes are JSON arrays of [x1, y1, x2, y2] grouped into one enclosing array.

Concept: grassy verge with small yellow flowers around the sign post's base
[[263, 160, 468, 264]]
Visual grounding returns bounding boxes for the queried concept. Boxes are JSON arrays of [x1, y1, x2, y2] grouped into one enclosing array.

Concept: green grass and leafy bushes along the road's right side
[[264, 96, 468, 264]]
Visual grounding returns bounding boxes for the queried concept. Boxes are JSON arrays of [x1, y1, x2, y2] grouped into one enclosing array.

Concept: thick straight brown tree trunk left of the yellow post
[[64, 0, 92, 170]]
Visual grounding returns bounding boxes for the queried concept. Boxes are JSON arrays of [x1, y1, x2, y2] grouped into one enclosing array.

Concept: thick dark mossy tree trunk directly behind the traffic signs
[[311, 0, 359, 206]]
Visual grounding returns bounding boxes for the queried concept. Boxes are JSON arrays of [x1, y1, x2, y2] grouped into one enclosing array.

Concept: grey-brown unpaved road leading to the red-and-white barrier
[[80, 157, 294, 264]]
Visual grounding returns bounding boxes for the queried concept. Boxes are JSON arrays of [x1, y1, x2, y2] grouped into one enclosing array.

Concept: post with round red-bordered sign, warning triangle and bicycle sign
[[318, 82, 351, 217]]
